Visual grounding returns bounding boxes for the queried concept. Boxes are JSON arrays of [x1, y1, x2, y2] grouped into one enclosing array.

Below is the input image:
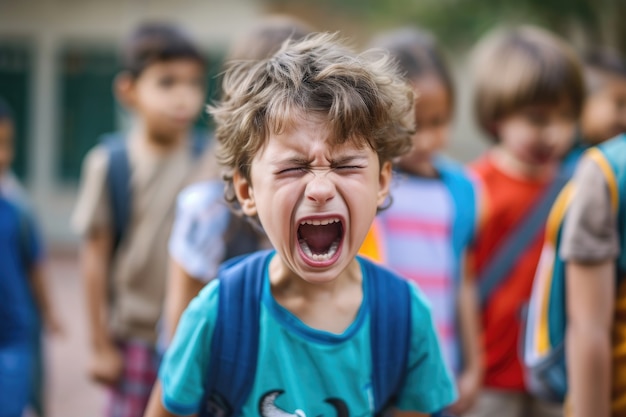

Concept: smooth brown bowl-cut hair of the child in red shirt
[[472, 26, 585, 140]]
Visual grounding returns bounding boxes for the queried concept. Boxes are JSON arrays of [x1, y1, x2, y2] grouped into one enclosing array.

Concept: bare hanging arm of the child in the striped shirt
[[450, 254, 483, 414]]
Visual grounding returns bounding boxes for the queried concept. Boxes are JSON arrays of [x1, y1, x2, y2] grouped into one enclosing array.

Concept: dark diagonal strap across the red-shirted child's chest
[[477, 154, 576, 305]]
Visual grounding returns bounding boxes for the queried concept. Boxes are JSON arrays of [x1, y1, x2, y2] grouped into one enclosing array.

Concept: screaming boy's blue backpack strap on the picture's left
[[198, 251, 273, 417]]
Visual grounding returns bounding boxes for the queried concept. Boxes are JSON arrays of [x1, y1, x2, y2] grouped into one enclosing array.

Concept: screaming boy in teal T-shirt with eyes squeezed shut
[[146, 34, 455, 417]]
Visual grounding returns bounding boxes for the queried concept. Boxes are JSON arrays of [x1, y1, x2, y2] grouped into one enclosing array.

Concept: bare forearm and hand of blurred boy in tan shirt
[[80, 229, 123, 384]]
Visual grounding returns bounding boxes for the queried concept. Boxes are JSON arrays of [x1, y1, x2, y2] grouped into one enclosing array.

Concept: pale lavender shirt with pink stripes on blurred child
[[377, 173, 460, 372]]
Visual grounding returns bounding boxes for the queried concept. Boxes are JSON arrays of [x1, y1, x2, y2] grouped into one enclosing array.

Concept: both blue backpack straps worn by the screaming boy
[[198, 250, 412, 417]]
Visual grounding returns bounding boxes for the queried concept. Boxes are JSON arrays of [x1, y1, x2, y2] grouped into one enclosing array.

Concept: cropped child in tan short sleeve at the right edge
[[560, 134, 626, 417]]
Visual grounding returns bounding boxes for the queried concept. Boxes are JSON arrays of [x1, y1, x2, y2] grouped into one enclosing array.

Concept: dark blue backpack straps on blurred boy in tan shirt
[[100, 131, 207, 252]]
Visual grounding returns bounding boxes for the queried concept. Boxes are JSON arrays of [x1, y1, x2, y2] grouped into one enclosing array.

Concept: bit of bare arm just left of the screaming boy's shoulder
[[165, 258, 205, 340]]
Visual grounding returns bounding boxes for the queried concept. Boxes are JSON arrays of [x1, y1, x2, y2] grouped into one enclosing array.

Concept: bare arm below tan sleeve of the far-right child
[[566, 260, 615, 417]]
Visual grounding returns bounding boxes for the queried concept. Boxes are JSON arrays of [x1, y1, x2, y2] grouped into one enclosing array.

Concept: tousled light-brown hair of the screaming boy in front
[[209, 33, 414, 206]]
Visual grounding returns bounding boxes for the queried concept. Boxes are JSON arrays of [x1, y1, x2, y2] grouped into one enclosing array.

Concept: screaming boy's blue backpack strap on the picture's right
[[359, 258, 412, 415]]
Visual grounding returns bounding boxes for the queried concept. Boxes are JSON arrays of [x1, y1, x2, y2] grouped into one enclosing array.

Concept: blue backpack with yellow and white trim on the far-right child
[[522, 145, 621, 403]]
